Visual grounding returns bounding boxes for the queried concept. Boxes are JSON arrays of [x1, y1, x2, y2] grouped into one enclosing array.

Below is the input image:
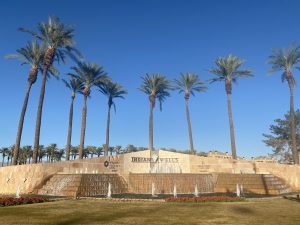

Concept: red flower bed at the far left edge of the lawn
[[0, 197, 49, 206]]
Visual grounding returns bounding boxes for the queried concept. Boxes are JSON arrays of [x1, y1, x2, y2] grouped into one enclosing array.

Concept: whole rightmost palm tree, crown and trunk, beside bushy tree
[[268, 45, 300, 164]]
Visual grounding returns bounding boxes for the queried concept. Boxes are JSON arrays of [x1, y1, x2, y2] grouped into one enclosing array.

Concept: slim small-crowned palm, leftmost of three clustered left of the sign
[[63, 77, 84, 161]]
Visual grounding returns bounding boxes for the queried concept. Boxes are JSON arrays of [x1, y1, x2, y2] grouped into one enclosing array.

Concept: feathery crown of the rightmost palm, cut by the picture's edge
[[268, 44, 300, 83]]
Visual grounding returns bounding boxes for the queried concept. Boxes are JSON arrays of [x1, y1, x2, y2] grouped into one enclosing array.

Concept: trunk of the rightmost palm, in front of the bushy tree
[[288, 78, 299, 164]]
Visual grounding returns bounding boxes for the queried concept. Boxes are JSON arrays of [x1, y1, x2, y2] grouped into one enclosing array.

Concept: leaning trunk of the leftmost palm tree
[[13, 81, 32, 165]]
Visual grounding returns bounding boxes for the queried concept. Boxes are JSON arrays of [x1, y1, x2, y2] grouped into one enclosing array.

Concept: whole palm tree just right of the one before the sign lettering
[[175, 73, 206, 153]]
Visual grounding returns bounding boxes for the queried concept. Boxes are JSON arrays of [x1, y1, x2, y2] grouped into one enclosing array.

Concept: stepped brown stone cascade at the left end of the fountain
[[38, 174, 127, 197]]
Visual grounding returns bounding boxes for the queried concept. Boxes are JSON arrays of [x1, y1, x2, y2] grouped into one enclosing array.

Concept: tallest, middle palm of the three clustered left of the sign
[[69, 62, 109, 159]]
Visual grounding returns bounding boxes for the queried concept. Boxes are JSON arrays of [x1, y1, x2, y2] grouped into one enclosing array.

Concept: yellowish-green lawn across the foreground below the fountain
[[0, 198, 300, 225]]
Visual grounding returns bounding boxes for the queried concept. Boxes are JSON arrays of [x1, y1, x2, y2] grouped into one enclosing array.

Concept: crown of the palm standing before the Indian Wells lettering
[[139, 73, 175, 110]]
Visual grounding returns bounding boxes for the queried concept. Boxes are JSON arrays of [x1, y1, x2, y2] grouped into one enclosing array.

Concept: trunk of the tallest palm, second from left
[[32, 66, 48, 164]]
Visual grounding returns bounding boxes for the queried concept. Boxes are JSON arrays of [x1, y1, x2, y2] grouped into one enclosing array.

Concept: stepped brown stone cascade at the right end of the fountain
[[214, 174, 289, 195]]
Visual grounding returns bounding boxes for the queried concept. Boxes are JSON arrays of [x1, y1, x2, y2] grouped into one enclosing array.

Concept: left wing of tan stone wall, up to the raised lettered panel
[[0, 156, 123, 194]]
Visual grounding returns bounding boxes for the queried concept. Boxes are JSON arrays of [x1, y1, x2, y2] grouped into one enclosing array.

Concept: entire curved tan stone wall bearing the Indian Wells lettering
[[0, 150, 300, 194]]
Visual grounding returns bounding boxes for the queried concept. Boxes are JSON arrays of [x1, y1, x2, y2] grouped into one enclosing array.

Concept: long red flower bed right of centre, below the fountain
[[165, 195, 243, 202]]
